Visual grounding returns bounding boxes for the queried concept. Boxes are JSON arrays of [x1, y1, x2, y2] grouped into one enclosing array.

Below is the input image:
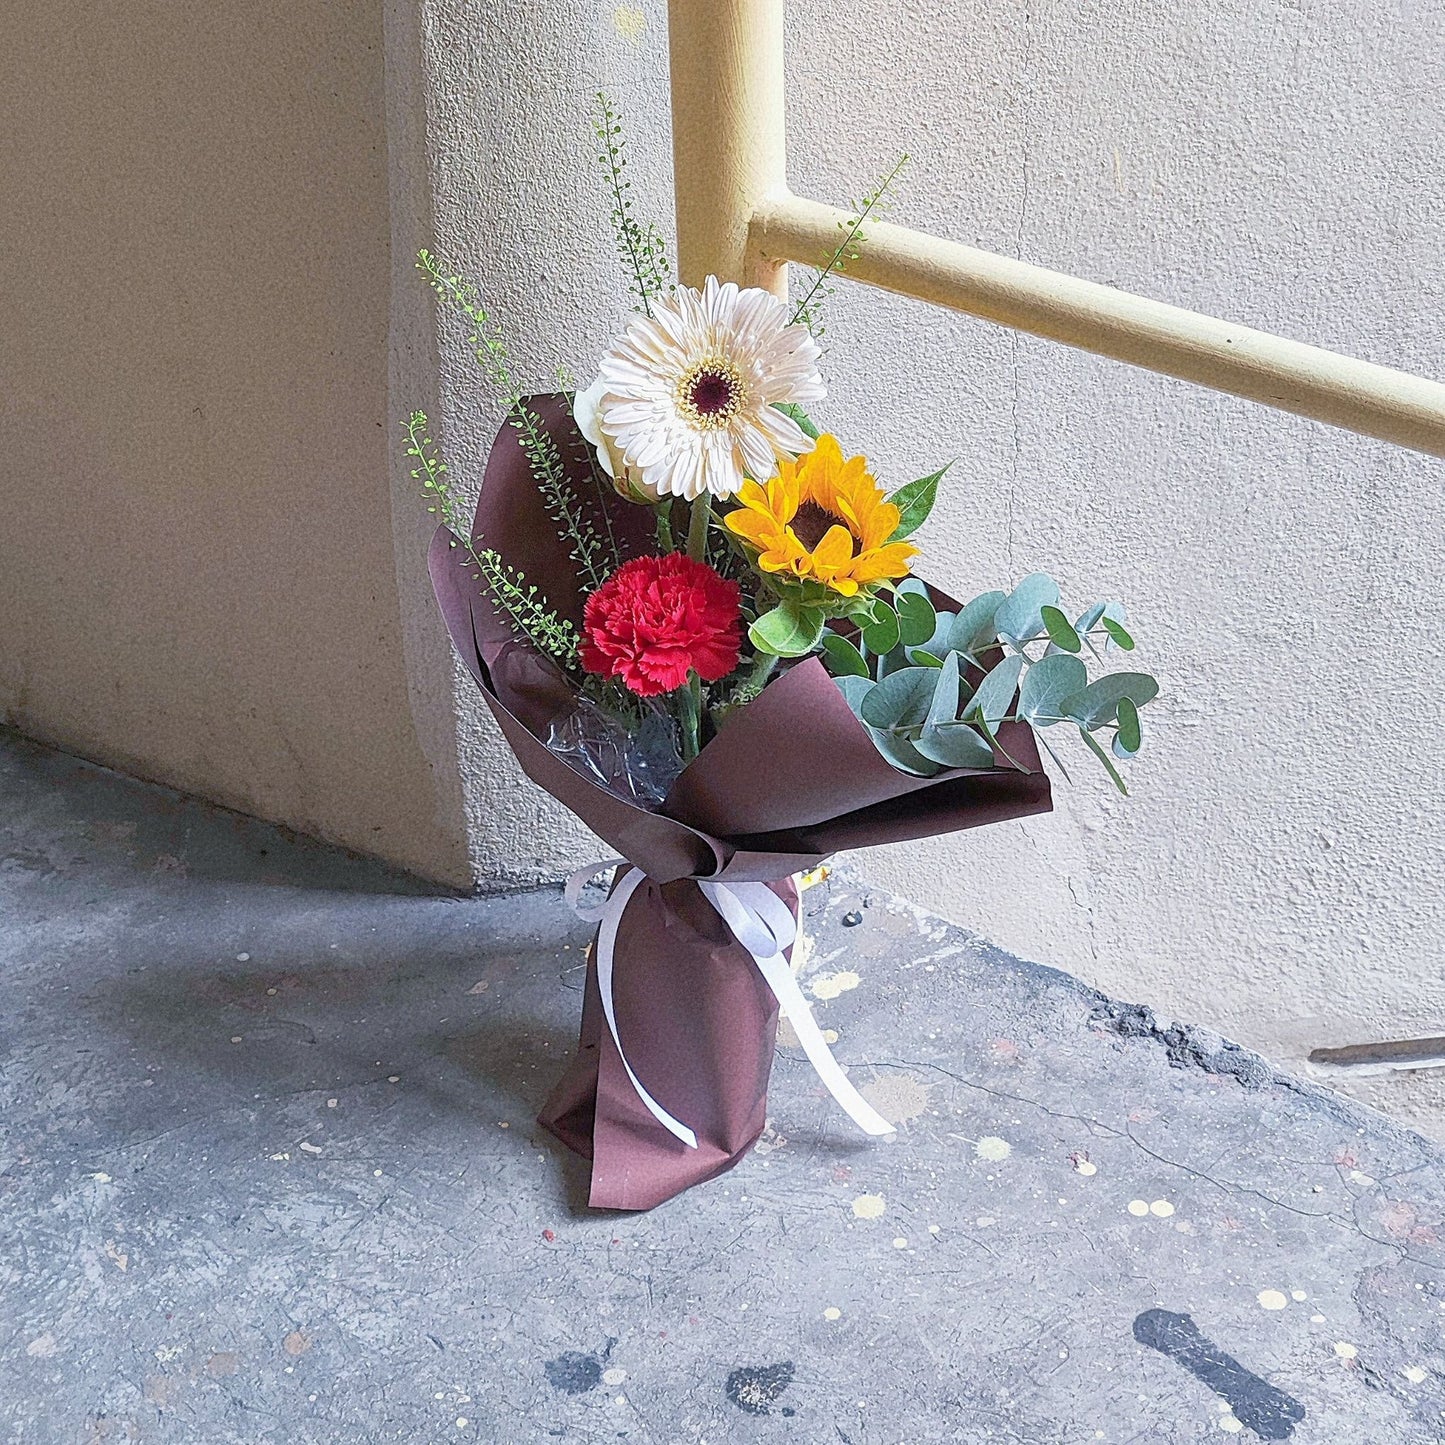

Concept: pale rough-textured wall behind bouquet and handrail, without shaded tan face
[[429, 0, 1445, 1111]]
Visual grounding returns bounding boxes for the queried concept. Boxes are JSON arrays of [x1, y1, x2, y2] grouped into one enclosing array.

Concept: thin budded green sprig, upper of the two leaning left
[[416, 250, 620, 591]]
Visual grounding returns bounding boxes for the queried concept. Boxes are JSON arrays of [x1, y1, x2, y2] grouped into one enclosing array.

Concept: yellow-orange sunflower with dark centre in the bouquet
[[723, 435, 918, 597]]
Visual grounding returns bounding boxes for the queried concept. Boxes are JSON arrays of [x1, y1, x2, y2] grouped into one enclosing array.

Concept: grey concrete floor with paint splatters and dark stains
[[0, 734, 1445, 1445]]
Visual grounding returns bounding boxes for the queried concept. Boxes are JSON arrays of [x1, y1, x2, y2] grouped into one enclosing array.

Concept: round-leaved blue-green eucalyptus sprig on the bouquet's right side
[[816, 572, 1159, 795]]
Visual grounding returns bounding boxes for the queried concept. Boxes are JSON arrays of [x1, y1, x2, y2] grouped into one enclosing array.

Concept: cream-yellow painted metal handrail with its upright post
[[668, 0, 1445, 457]]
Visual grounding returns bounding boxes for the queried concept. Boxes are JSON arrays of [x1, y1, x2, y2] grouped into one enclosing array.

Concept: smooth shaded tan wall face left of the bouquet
[[0, 0, 473, 883]]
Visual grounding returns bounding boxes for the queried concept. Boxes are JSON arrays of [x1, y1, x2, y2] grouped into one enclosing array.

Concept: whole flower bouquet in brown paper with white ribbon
[[406, 103, 1157, 1209]]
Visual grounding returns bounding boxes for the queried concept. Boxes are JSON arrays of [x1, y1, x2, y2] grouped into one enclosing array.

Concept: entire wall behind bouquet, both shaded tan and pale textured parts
[[0, 0, 1445, 1117]]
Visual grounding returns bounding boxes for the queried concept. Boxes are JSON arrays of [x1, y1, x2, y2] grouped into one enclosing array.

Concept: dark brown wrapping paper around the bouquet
[[429, 397, 1051, 1209]]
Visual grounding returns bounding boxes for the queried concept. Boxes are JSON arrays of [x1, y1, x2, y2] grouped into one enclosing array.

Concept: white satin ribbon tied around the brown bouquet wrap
[[565, 858, 894, 1149]]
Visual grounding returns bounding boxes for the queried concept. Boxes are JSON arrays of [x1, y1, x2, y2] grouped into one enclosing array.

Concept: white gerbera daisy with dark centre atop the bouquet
[[588, 276, 827, 501]]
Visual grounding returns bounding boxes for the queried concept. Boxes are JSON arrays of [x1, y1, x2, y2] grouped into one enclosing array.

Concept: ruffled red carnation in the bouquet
[[581, 552, 741, 698]]
